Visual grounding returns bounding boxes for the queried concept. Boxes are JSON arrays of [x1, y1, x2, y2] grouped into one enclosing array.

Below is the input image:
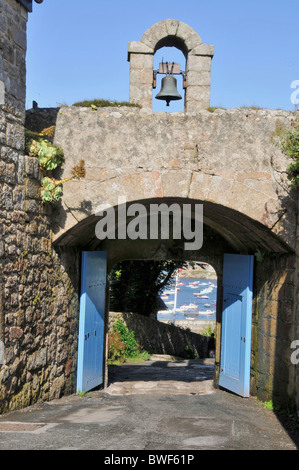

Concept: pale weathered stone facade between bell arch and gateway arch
[[51, 108, 296, 253]]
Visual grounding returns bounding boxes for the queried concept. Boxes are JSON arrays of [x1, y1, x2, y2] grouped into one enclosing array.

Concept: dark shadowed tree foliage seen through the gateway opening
[[110, 260, 186, 316]]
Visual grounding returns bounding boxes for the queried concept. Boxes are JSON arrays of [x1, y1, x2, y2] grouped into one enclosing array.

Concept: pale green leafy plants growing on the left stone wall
[[26, 126, 85, 204]]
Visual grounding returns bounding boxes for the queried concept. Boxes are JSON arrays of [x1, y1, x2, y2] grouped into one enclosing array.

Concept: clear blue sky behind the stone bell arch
[[26, 0, 299, 111]]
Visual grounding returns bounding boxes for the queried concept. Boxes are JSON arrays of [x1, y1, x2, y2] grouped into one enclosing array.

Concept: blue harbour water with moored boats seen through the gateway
[[157, 278, 217, 320]]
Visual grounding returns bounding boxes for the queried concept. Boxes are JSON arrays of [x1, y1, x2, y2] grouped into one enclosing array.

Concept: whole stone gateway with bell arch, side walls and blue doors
[[0, 10, 299, 412]]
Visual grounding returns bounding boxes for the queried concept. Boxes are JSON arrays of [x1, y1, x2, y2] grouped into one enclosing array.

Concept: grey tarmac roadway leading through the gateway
[[0, 356, 298, 452]]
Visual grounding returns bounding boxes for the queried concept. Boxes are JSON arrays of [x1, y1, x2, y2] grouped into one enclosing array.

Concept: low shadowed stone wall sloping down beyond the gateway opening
[[108, 312, 209, 358]]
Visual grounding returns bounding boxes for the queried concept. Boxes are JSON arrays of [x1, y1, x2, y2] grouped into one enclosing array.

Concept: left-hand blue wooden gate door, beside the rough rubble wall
[[77, 251, 107, 392]]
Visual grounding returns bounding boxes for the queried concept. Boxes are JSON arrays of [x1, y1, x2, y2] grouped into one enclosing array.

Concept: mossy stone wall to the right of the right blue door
[[251, 255, 298, 408]]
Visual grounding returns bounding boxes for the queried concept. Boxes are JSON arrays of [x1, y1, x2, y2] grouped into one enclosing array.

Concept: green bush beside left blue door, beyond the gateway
[[108, 319, 150, 365]]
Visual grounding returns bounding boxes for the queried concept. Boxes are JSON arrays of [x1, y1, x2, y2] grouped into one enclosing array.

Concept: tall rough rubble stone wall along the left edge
[[0, 0, 79, 414]]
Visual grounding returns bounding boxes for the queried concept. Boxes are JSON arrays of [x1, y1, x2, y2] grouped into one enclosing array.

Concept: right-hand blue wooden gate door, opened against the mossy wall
[[219, 254, 254, 397]]
